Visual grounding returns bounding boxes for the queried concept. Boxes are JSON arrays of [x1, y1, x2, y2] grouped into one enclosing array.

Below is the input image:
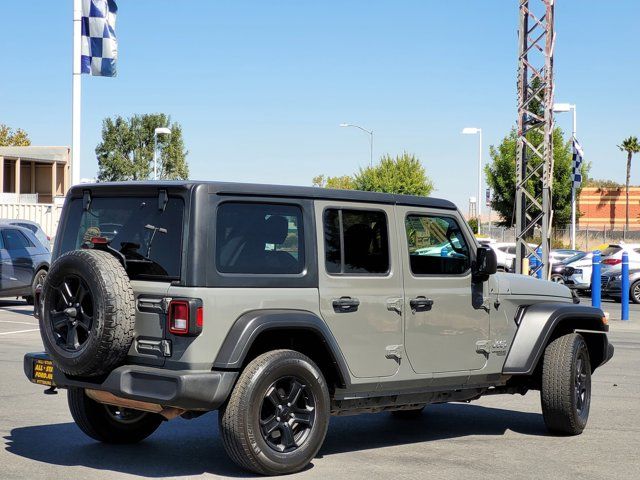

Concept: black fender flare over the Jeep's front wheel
[[502, 302, 609, 375]]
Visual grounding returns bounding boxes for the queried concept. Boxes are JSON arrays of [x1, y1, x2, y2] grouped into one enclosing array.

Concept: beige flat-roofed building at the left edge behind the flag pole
[[0, 147, 70, 203]]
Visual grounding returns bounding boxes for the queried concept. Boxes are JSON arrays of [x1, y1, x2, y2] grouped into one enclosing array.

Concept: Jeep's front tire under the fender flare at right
[[540, 333, 591, 435]]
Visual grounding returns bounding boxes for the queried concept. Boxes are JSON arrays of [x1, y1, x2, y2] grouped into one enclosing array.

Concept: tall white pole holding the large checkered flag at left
[[71, 0, 82, 185]]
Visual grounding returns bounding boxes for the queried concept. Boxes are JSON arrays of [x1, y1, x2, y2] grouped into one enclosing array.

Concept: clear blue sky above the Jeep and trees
[[0, 0, 640, 211]]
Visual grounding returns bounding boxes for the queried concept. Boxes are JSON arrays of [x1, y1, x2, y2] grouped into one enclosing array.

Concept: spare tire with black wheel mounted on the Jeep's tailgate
[[40, 249, 135, 377]]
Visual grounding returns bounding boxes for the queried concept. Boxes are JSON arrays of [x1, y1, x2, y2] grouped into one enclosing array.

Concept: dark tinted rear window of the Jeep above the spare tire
[[59, 197, 184, 280]]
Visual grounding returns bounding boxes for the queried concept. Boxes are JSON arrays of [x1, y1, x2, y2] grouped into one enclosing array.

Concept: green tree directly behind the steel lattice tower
[[485, 128, 589, 227]]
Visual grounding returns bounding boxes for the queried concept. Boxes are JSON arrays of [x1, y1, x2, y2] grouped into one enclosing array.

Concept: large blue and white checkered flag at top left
[[80, 0, 118, 77]]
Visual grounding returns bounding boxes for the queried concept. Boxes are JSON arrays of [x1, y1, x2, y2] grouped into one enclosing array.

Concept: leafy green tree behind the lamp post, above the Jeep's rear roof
[[96, 113, 189, 182]]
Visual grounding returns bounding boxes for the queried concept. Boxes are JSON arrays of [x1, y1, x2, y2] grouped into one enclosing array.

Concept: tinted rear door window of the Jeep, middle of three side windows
[[323, 209, 389, 274]]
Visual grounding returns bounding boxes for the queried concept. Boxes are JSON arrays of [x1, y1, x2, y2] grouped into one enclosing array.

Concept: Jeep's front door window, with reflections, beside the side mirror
[[405, 215, 471, 275]]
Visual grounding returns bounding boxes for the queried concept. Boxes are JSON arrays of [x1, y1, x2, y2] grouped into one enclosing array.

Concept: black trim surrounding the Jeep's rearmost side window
[[212, 198, 309, 279]]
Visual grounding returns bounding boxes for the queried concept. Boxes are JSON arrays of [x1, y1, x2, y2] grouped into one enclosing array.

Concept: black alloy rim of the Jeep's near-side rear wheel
[[260, 377, 316, 453]]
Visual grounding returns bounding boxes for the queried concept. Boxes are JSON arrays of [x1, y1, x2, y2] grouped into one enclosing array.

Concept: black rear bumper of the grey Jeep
[[24, 353, 239, 410]]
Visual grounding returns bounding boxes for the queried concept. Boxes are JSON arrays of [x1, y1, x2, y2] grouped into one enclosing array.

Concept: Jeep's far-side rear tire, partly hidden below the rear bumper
[[67, 388, 163, 444]]
